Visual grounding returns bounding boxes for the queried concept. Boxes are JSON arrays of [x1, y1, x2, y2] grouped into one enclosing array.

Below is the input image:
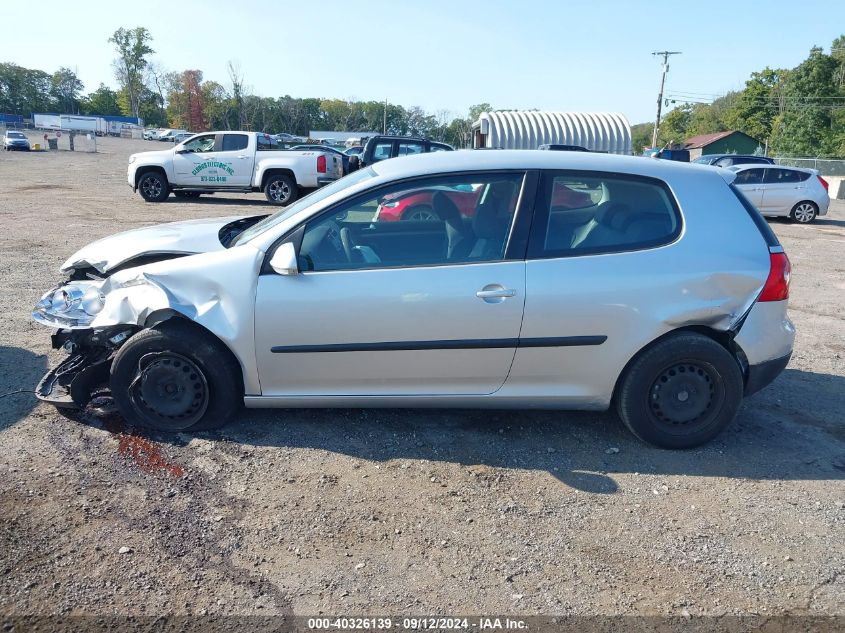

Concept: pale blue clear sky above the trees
[[0, 0, 845, 123]]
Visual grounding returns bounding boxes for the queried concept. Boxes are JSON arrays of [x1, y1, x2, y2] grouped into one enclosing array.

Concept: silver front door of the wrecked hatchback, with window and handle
[[255, 168, 525, 396]]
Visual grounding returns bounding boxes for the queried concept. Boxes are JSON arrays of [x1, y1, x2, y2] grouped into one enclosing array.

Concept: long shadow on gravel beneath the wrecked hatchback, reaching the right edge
[[79, 369, 845, 494]]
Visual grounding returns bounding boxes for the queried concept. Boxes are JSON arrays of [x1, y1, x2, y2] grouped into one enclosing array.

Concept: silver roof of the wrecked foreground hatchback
[[373, 150, 734, 182]]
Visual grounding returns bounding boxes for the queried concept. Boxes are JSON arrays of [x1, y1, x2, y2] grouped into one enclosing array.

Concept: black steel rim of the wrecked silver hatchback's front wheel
[[129, 352, 210, 430]]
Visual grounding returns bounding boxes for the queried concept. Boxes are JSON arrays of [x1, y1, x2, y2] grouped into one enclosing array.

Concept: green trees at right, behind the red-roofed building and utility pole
[[632, 35, 845, 158]]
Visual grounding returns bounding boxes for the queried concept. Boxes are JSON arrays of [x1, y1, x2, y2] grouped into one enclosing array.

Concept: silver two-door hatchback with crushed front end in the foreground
[[33, 151, 794, 448]]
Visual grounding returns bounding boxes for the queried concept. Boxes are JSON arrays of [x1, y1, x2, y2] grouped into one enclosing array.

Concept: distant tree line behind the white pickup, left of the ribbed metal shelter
[[0, 27, 484, 147]]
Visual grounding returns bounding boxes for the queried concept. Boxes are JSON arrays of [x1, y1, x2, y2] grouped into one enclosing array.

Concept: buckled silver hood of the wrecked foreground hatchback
[[62, 216, 251, 274]]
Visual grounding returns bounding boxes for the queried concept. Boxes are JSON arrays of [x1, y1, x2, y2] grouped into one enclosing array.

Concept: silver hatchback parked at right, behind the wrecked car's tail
[[729, 165, 830, 224]]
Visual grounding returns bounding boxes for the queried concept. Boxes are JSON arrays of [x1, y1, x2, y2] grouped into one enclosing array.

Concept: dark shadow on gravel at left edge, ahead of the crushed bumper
[[0, 345, 47, 431]]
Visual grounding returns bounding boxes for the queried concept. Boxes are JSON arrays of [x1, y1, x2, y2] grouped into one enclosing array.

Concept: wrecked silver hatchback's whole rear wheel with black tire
[[616, 332, 744, 449]]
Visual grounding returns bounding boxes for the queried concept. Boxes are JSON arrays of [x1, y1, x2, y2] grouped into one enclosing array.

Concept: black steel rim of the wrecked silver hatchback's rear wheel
[[648, 360, 725, 435]]
